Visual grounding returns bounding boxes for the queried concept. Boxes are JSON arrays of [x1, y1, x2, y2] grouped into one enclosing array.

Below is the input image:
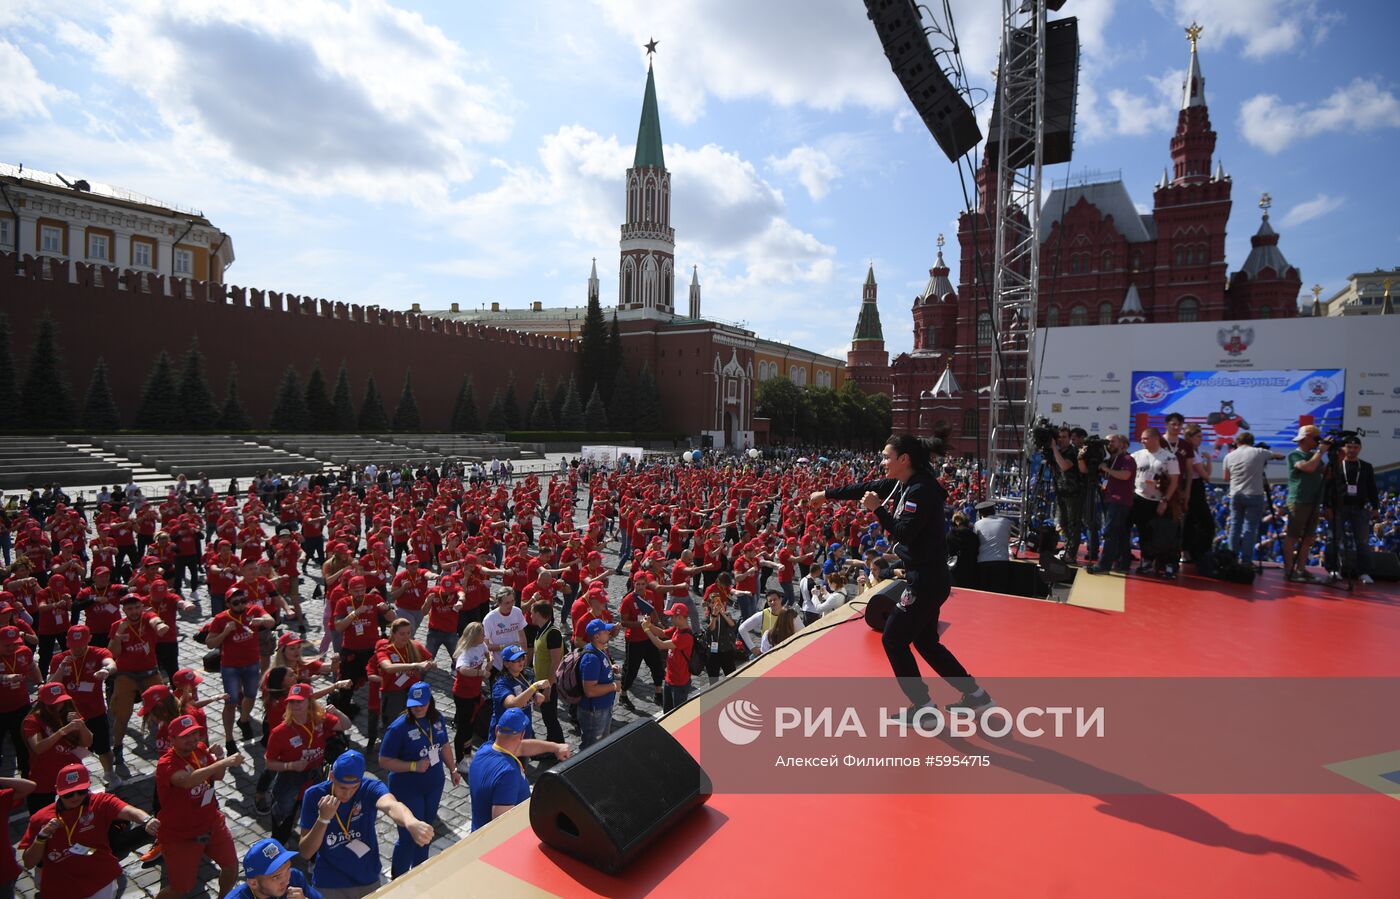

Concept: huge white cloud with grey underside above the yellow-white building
[[55, 0, 511, 202]]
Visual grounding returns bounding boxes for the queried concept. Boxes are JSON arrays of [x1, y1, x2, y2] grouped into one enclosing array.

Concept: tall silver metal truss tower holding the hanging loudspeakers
[[987, 0, 1046, 546]]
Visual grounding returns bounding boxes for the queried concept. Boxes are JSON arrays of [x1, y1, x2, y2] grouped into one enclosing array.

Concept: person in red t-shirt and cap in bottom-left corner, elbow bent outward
[[19, 763, 160, 899]]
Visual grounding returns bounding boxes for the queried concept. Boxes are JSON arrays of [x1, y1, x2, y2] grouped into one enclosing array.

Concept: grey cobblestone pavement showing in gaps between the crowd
[[0, 459, 706, 898]]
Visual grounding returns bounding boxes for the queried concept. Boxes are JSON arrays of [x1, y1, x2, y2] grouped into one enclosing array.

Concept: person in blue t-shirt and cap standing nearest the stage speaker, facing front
[[379, 681, 462, 877]]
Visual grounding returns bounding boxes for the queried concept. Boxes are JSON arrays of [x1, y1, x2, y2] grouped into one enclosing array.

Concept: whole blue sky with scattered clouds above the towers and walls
[[0, 0, 1400, 351]]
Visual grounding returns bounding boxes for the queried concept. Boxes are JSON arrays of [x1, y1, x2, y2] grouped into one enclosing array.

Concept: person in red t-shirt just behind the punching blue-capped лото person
[[266, 683, 350, 846]]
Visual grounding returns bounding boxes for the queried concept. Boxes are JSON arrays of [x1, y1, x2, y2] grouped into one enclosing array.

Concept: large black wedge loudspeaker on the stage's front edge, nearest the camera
[[529, 717, 714, 874]]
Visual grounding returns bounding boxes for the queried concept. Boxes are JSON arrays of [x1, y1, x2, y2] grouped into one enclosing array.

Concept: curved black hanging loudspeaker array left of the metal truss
[[865, 0, 981, 161]]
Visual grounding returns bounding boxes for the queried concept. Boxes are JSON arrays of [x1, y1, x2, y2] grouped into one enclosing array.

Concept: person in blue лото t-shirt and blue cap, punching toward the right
[[298, 749, 433, 899]]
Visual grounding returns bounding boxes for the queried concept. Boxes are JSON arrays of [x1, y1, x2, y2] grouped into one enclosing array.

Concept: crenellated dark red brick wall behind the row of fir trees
[[0, 253, 578, 430]]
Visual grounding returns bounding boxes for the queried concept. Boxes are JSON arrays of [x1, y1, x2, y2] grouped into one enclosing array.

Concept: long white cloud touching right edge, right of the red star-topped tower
[[1239, 78, 1400, 154]]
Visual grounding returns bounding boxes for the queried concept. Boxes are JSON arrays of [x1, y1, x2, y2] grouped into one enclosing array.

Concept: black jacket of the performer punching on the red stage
[[826, 471, 949, 594]]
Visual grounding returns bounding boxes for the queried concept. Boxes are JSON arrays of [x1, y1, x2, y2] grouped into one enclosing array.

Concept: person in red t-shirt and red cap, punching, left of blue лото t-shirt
[[155, 716, 244, 899]]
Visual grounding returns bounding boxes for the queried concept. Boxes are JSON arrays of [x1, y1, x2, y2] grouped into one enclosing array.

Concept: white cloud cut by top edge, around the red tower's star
[[1156, 0, 1341, 59]]
